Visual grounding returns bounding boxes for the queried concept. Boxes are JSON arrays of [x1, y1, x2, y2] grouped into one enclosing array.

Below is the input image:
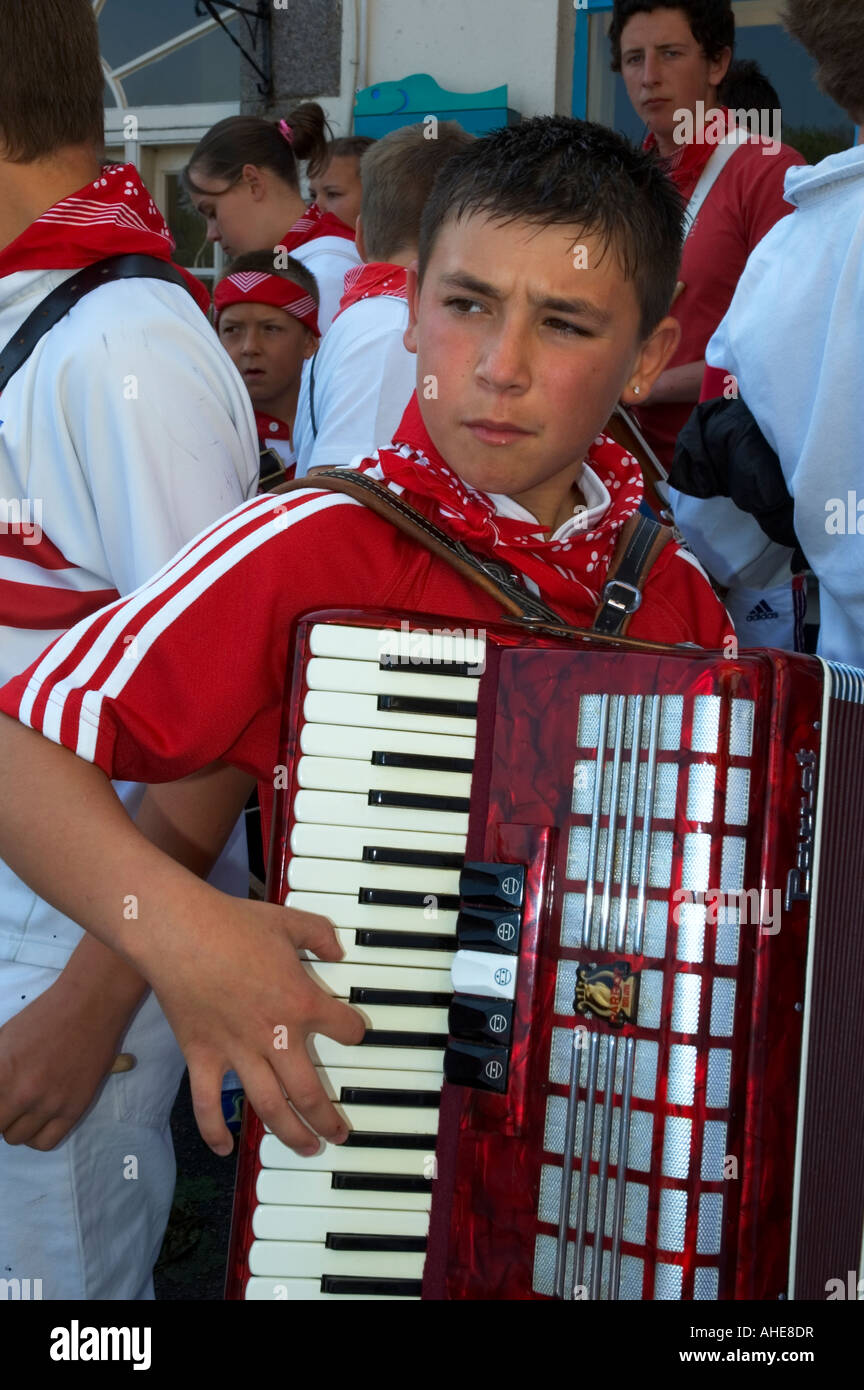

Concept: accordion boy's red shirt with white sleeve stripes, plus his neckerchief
[[0, 400, 732, 839]]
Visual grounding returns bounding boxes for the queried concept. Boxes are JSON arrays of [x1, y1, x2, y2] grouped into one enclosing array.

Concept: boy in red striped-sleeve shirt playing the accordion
[[0, 117, 729, 1154]]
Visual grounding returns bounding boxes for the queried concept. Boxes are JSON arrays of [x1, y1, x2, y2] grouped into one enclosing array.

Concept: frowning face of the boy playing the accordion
[[406, 214, 678, 525]]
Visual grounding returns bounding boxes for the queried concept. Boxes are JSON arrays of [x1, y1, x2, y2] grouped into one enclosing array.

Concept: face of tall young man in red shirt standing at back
[[621, 8, 732, 145]]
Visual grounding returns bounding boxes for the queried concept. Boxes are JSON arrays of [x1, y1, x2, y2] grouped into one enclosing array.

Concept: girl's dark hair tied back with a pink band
[[181, 101, 329, 193]]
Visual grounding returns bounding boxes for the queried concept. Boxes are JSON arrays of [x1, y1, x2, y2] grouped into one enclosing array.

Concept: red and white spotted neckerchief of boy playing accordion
[[357, 393, 645, 603]]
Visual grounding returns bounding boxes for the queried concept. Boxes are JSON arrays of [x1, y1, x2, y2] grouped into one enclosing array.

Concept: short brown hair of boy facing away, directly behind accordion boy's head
[[360, 121, 475, 261]]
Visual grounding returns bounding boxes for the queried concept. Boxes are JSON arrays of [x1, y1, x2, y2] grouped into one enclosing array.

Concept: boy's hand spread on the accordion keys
[[142, 890, 365, 1155]]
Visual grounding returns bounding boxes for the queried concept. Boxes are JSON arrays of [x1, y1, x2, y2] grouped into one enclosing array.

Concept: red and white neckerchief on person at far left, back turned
[[0, 164, 210, 314]]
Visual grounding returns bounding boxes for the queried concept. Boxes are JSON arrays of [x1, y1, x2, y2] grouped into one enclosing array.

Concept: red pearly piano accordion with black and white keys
[[228, 613, 864, 1300]]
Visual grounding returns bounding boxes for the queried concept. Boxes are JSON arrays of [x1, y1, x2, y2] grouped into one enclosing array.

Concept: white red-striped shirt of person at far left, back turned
[[0, 262, 258, 969]]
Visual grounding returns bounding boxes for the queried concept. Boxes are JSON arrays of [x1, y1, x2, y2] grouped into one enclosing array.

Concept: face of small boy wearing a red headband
[[218, 304, 318, 409]]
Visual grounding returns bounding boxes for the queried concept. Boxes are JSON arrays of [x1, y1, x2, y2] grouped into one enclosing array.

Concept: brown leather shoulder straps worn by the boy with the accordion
[[272, 468, 671, 637]]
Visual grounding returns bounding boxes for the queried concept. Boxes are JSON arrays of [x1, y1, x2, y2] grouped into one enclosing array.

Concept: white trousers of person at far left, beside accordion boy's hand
[[0, 960, 185, 1300]]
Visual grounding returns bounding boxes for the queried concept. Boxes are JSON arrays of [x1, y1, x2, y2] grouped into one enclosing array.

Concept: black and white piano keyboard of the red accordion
[[244, 624, 483, 1300]]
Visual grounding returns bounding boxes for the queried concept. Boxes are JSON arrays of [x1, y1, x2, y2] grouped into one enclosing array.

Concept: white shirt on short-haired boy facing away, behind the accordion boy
[[294, 295, 417, 478]]
